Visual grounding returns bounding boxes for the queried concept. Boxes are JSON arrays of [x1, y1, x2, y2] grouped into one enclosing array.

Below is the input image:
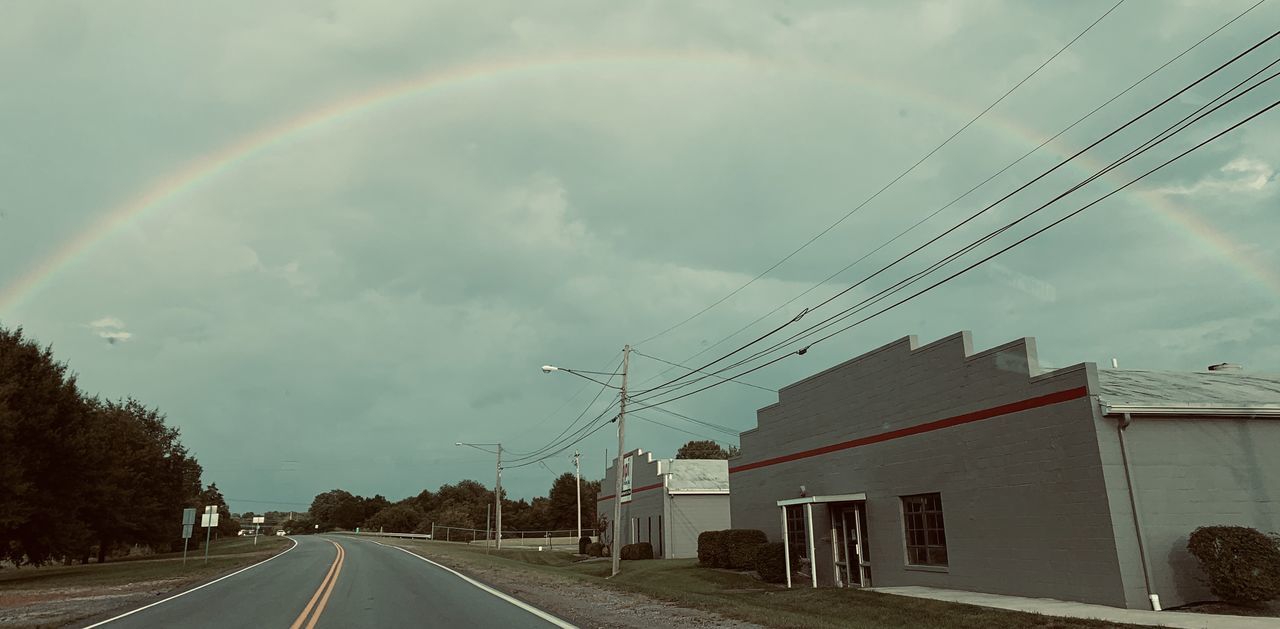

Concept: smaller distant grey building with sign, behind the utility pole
[[595, 450, 730, 559]]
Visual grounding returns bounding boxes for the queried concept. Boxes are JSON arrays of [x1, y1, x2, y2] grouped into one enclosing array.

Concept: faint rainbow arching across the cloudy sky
[[0, 51, 1280, 314]]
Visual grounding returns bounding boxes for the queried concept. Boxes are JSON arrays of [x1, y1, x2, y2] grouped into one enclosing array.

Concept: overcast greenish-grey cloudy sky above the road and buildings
[[0, 0, 1280, 511]]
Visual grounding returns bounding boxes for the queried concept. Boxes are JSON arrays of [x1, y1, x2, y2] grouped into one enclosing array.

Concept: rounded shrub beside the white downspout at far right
[[1187, 527, 1280, 606]]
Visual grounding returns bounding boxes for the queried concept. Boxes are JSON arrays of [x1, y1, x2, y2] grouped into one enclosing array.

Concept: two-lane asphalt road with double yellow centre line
[[90, 535, 570, 629]]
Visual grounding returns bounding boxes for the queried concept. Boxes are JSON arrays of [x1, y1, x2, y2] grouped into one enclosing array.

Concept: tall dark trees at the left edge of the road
[[0, 327, 230, 566]]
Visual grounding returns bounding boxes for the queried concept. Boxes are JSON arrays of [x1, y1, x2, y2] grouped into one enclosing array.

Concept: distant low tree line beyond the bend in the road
[[302, 473, 600, 533]]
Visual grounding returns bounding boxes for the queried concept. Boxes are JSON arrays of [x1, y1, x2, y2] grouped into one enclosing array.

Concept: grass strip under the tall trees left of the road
[[0, 537, 291, 592]]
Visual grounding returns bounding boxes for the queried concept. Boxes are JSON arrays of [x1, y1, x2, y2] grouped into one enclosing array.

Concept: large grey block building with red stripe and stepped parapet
[[730, 332, 1280, 609]]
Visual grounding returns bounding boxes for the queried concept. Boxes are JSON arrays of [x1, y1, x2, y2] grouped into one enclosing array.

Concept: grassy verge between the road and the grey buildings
[[384, 541, 1152, 629]]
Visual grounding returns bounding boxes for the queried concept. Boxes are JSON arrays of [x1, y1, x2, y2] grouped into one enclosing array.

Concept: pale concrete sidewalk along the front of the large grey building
[[868, 585, 1280, 629]]
